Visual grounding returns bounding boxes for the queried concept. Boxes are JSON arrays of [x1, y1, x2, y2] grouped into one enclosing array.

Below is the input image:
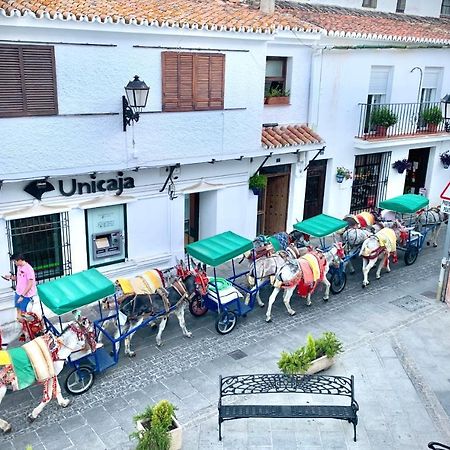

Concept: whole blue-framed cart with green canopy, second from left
[[186, 231, 268, 334]]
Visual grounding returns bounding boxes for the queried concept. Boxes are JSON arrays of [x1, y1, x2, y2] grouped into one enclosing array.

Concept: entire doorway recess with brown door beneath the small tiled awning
[[257, 164, 290, 235]]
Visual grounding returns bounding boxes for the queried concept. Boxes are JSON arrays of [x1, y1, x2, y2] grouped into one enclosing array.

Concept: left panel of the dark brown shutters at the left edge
[[0, 45, 24, 117]]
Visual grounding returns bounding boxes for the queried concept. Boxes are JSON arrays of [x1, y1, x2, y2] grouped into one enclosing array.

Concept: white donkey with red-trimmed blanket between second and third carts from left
[[266, 242, 345, 322]]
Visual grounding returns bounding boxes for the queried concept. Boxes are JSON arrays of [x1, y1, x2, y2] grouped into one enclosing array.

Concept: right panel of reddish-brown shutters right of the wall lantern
[[194, 54, 225, 110]]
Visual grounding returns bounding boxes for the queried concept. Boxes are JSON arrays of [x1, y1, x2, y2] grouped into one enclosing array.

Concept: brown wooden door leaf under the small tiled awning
[[264, 174, 289, 235]]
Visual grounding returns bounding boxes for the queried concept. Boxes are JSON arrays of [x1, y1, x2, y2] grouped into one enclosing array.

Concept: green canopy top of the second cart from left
[[186, 231, 253, 267]]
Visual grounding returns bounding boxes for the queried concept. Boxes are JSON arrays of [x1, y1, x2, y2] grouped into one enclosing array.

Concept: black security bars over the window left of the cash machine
[[7, 212, 72, 281]]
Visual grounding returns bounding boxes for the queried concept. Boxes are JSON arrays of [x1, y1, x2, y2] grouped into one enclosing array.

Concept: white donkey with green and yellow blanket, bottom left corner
[[0, 318, 97, 433]]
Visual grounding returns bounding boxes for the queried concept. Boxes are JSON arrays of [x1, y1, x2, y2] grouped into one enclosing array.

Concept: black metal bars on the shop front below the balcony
[[350, 152, 391, 214]]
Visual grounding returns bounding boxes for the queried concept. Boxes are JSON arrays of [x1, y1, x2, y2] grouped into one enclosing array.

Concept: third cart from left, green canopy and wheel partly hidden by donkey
[[294, 214, 354, 294]]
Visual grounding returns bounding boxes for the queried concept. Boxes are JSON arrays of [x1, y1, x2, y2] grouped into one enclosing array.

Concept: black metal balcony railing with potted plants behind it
[[357, 102, 450, 140]]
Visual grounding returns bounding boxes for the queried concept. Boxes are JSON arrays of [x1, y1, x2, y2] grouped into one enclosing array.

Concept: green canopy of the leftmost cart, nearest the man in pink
[[38, 269, 115, 315]]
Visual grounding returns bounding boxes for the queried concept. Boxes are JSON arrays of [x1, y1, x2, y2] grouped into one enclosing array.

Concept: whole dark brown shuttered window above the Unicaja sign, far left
[[0, 45, 58, 117]]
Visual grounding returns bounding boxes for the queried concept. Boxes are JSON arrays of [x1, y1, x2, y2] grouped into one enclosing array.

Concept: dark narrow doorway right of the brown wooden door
[[303, 159, 327, 220]]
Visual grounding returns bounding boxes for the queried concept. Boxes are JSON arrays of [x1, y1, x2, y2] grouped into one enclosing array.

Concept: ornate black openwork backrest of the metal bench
[[220, 373, 354, 400]]
